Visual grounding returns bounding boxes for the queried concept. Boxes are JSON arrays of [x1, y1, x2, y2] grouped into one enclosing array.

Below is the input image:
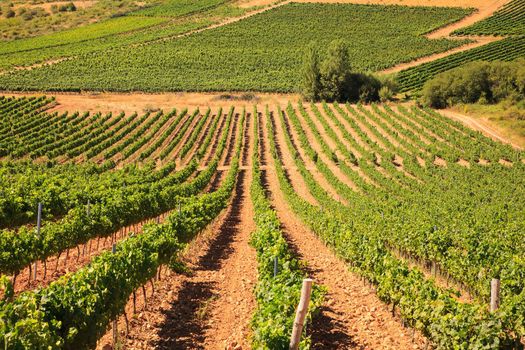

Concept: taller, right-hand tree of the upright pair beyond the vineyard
[[320, 40, 351, 101]]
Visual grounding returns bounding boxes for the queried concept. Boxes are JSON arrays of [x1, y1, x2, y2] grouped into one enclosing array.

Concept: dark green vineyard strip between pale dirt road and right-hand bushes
[[397, 37, 525, 92]]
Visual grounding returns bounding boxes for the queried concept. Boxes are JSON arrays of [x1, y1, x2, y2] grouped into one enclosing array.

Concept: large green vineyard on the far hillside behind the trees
[[0, 3, 470, 92]]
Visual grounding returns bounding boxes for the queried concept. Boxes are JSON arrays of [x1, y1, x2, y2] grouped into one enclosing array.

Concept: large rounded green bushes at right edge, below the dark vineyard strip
[[421, 59, 525, 108]]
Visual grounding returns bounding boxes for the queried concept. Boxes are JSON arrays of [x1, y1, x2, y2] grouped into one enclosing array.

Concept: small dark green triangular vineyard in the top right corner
[[454, 0, 525, 35]]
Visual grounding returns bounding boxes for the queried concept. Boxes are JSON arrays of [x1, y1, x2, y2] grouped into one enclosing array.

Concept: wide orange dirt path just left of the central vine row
[[155, 170, 257, 349]]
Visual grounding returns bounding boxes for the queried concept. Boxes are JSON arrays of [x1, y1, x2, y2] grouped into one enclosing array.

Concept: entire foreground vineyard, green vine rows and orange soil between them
[[0, 97, 525, 348]]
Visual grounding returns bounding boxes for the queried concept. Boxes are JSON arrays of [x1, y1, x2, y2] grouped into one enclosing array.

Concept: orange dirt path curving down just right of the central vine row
[[263, 110, 424, 349]]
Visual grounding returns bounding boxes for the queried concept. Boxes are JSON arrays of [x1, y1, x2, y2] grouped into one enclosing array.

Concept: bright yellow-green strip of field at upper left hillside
[[0, 4, 235, 71]]
